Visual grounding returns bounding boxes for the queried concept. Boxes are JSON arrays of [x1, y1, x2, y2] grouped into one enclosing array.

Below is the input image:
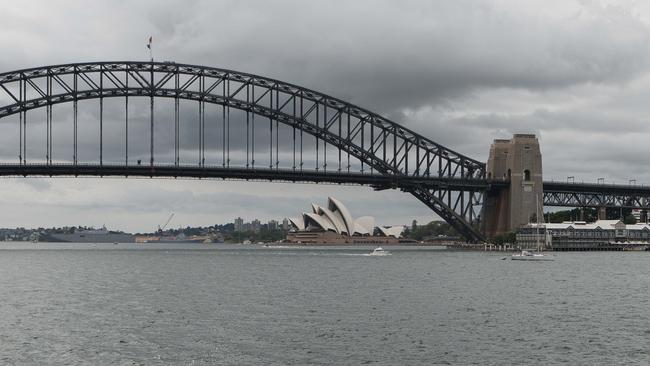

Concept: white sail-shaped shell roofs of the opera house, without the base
[[289, 197, 404, 238]]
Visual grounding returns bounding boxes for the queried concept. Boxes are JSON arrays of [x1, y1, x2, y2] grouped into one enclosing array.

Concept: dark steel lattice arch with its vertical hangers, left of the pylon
[[0, 61, 485, 241]]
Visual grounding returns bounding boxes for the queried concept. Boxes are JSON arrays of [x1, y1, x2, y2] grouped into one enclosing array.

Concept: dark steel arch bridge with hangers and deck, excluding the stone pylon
[[0, 61, 650, 241]]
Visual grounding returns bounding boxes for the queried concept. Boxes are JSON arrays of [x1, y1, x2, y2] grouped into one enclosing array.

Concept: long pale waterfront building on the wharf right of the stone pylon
[[517, 220, 650, 250]]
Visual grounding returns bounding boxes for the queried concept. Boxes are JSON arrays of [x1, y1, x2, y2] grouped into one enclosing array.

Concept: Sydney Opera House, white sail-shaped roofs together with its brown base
[[287, 197, 404, 244]]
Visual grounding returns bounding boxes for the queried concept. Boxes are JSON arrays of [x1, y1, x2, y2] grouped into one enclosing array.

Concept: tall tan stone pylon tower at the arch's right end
[[481, 134, 544, 238]]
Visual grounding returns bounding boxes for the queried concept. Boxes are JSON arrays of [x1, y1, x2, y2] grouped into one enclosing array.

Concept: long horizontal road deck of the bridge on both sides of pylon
[[5, 163, 650, 209]]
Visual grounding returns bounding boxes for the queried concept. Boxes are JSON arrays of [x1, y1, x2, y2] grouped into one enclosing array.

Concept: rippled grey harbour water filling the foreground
[[0, 243, 650, 365]]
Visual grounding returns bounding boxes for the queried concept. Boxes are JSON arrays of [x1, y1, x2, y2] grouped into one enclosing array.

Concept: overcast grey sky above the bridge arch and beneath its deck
[[0, 0, 650, 231]]
